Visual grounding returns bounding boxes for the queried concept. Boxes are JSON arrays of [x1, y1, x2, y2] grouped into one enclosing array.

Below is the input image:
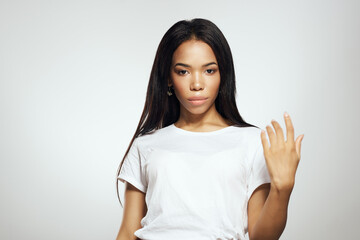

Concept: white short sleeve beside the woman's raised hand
[[247, 143, 271, 201]]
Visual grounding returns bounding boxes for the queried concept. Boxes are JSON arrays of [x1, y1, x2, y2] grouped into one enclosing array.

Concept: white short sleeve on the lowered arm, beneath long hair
[[117, 139, 147, 193]]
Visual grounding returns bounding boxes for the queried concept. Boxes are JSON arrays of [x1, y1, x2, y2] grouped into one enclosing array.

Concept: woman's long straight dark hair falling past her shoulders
[[116, 18, 258, 206]]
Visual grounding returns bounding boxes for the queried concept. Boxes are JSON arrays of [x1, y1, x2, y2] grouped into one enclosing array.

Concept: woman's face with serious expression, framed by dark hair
[[169, 40, 220, 114]]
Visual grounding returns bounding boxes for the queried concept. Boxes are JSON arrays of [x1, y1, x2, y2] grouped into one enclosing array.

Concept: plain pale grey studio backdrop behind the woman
[[0, 0, 360, 240]]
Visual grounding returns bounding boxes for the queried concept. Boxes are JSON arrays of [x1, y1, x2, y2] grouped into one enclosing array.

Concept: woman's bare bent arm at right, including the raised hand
[[248, 113, 304, 240]]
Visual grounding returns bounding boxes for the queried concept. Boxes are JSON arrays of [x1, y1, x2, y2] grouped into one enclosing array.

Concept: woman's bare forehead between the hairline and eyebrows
[[172, 39, 216, 65]]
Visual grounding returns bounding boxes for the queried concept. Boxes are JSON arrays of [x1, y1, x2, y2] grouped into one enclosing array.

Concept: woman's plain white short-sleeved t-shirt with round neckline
[[118, 124, 270, 240]]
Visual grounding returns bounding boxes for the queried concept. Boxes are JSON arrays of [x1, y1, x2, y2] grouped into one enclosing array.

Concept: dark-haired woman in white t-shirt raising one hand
[[117, 19, 304, 240]]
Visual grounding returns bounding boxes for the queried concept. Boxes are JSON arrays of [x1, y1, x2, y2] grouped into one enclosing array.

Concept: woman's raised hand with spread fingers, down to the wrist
[[260, 112, 304, 192]]
